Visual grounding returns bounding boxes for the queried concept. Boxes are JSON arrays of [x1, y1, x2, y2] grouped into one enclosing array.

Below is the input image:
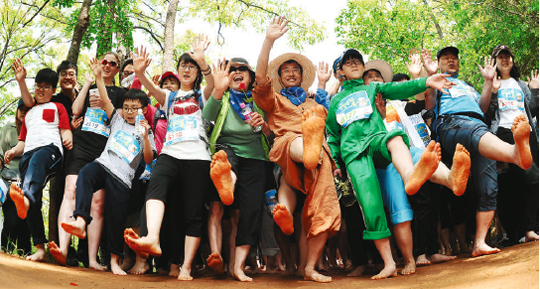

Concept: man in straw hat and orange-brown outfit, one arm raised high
[[253, 17, 341, 282]]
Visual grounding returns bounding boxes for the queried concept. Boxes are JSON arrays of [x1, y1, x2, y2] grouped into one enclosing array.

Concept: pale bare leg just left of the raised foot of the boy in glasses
[[53, 175, 78, 265]]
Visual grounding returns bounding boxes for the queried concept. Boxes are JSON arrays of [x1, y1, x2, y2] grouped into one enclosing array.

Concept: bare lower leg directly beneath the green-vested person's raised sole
[[206, 202, 224, 274]]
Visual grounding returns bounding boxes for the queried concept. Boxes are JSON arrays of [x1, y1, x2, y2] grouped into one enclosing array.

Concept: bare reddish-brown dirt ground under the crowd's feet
[[0, 242, 539, 289]]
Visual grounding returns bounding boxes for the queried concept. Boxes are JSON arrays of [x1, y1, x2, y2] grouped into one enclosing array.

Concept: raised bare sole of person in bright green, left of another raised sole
[[405, 141, 441, 195]]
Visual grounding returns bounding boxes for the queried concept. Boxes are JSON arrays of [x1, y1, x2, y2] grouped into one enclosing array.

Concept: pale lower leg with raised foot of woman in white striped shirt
[[124, 199, 165, 256]]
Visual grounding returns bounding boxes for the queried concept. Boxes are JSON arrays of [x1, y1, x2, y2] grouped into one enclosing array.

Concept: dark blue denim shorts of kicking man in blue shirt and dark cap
[[437, 115, 498, 212]]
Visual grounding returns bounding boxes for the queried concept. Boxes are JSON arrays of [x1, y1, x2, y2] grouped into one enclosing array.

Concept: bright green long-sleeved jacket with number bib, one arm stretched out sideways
[[326, 78, 427, 169]]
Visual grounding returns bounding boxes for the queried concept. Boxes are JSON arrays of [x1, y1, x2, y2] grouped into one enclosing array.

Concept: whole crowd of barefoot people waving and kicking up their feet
[[0, 17, 539, 282]]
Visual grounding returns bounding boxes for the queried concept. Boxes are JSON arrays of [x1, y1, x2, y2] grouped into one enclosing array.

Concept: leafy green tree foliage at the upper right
[[336, 0, 539, 89]]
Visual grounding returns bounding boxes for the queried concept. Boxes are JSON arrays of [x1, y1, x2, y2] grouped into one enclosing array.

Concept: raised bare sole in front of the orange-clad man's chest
[[302, 105, 328, 170]]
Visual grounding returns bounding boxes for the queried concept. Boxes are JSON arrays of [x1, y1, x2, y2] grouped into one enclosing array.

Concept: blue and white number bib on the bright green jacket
[[336, 91, 373, 127]]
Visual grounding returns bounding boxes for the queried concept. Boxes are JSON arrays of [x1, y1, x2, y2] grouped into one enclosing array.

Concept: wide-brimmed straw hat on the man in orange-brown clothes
[[266, 53, 315, 92]]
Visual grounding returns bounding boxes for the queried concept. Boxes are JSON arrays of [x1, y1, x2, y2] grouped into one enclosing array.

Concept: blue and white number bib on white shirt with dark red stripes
[[163, 115, 199, 147]]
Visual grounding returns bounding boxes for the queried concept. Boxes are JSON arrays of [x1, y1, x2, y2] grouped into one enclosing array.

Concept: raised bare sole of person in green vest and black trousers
[[210, 151, 234, 206]]
